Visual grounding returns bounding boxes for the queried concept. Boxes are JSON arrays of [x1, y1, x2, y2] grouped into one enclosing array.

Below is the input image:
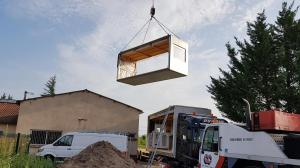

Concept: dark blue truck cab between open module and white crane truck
[[176, 114, 209, 166]]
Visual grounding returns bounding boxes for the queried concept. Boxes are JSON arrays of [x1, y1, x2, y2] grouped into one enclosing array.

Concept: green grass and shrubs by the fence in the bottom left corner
[[0, 135, 54, 168]]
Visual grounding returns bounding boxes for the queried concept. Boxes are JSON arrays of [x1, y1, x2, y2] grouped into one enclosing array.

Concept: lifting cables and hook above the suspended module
[[122, 0, 180, 51]]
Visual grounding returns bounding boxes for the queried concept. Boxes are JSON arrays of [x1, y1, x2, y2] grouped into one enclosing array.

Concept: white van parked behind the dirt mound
[[36, 132, 128, 160]]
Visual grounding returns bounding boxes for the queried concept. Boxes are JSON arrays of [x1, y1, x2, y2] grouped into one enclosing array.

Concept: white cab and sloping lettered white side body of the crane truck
[[199, 123, 300, 168]]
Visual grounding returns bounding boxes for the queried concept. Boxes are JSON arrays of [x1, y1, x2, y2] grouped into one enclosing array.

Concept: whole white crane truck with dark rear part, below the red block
[[199, 123, 300, 168]]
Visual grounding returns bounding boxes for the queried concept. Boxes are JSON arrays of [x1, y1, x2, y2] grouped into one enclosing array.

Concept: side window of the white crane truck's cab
[[202, 127, 219, 152]]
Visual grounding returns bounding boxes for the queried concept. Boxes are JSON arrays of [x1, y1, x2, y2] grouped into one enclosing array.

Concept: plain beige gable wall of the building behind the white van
[[16, 91, 139, 155]]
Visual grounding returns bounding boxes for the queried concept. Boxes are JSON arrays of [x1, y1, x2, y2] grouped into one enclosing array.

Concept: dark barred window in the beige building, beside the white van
[[30, 130, 62, 145]]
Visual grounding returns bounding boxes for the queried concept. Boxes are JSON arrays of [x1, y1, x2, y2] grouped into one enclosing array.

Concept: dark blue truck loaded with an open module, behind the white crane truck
[[142, 105, 226, 167]]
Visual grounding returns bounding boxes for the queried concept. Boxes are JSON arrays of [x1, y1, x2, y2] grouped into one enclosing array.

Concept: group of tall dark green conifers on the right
[[208, 3, 300, 121]]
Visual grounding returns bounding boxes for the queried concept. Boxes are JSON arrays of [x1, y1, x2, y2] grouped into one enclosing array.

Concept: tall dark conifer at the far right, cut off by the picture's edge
[[274, 2, 300, 112]]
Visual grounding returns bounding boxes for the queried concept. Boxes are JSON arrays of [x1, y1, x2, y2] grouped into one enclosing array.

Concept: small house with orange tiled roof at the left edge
[[0, 100, 20, 135]]
